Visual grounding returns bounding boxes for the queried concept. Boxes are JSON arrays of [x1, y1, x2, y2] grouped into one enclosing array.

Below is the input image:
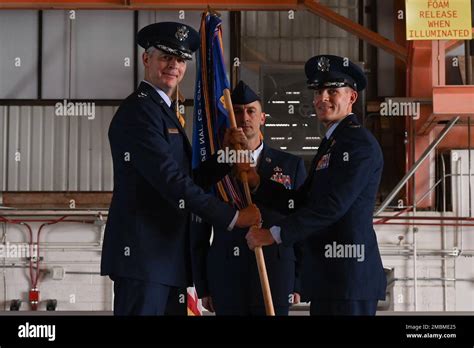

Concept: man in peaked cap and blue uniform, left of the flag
[[101, 22, 260, 315]]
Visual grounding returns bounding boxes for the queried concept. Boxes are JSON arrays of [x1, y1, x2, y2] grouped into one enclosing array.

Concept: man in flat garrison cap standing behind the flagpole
[[191, 81, 306, 315]]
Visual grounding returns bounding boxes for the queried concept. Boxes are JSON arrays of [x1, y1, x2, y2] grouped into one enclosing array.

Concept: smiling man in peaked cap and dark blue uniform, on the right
[[246, 55, 386, 315]]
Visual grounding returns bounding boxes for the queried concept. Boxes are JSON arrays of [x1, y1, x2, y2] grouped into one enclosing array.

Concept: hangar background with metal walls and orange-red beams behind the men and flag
[[0, 0, 474, 315]]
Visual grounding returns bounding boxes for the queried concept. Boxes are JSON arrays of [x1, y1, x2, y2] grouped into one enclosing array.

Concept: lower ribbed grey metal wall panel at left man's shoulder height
[[0, 106, 117, 191]]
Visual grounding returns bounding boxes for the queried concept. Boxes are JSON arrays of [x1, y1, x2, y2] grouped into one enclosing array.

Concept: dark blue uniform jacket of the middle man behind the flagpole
[[191, 145, 306, 310]]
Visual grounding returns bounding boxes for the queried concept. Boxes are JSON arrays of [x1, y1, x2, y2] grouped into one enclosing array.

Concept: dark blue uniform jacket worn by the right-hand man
[[255, 114, 386, 300]]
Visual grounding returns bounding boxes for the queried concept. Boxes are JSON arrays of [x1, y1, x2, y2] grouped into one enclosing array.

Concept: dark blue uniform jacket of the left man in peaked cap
[[101, 82, 236, 287]]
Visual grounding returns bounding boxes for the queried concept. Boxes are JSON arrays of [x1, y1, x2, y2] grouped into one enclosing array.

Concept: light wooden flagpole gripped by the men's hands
[[224, 88, 275, 316]]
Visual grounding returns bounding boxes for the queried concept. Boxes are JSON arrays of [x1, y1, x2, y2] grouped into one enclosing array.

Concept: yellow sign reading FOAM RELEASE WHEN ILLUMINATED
[[405, 0, 472, 40]]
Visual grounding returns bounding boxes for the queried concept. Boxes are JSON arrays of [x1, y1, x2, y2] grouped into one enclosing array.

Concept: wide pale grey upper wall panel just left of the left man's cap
[[42, 11, 134, 99]]
